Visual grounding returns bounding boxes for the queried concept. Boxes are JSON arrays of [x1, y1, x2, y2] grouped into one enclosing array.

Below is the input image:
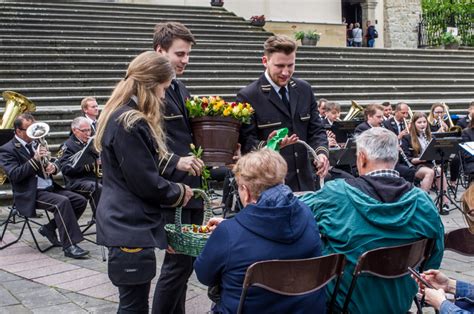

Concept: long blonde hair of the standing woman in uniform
[[94, 51, 174, 156]]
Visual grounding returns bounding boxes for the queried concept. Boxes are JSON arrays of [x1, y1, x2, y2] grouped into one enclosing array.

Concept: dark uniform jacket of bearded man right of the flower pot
[[237, 74, 329, 191]]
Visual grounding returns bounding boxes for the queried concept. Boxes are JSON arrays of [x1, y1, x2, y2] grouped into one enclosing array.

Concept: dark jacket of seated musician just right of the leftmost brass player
[[59, 135, 99, 188]]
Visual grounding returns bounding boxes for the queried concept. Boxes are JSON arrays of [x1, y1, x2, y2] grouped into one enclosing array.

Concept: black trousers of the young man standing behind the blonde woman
[[152, 209, 203, 314]]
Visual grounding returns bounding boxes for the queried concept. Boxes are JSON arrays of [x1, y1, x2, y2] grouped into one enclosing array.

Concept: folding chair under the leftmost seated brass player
[[0, 205, 54, 253]]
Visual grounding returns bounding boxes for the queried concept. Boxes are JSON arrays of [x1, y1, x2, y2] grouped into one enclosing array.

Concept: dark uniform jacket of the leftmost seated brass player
[[0, 138, 60, 217]]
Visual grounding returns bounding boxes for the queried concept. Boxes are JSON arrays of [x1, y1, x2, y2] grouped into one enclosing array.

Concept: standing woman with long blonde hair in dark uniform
[[95, 51, 192, 313]]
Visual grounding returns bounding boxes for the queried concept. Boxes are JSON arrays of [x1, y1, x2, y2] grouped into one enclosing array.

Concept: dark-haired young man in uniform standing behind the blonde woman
[[152, 22, 204, 314]]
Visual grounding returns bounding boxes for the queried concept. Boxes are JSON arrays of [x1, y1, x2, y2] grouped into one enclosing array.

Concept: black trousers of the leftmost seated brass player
[[36, 187, 87, 248]]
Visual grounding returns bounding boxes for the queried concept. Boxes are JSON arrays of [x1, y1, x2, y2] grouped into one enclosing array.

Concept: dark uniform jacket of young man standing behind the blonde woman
[[164, 80, 203, 209]]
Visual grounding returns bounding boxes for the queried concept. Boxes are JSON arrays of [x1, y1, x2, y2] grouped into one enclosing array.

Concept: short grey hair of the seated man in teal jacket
[[356, 127, 398, 166]]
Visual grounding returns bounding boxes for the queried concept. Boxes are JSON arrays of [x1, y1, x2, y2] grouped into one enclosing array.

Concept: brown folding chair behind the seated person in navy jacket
[[237, 254, 345, 313]]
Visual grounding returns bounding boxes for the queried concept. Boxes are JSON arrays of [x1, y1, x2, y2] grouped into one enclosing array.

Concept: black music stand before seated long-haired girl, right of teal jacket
[[420, 137, 461, 214]]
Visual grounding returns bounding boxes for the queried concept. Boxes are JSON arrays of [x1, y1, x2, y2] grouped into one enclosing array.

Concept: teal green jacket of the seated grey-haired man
[[300, 179, 444, 313]]
